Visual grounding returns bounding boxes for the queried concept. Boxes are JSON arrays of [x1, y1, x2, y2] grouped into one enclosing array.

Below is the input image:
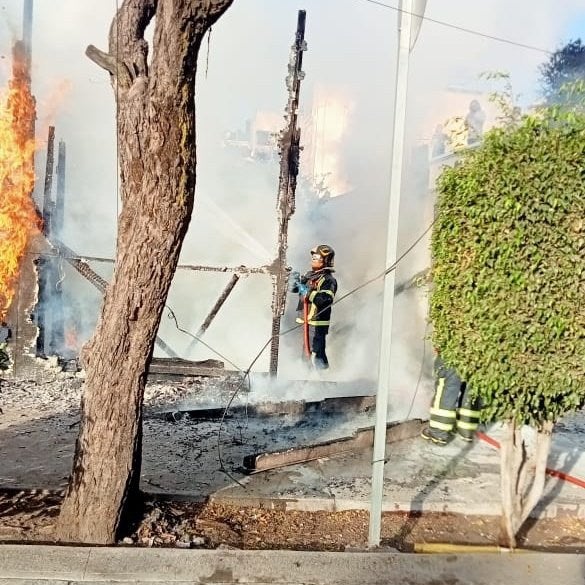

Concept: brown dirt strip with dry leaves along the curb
[[0, 491, 585, 554]]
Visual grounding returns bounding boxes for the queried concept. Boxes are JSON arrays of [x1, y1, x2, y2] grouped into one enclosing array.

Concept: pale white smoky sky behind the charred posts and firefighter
[[0, 0, 585, 410]]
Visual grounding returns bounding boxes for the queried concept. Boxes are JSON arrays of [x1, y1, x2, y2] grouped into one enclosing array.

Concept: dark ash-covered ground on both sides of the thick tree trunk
[[0, 372, 373, 498]]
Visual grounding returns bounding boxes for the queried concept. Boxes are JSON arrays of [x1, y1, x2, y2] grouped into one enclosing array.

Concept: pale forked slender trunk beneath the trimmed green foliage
[[499, 422, 554, 548]]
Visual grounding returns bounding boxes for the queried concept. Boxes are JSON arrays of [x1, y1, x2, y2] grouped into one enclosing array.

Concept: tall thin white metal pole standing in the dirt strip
[[368, 0, 426, 547]]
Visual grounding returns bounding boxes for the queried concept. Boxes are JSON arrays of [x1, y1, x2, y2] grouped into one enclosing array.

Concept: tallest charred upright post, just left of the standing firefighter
[[269, 10, 307, 376]]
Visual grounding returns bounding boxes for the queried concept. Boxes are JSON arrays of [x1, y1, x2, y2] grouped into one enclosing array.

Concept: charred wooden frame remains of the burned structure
[[5, 6, 306, 377]]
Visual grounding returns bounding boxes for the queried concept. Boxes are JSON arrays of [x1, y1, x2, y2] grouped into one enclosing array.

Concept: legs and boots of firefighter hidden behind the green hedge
[[421, 353, 480, 445]]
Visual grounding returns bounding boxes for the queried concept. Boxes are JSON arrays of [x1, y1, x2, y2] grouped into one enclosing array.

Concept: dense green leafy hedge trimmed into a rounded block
[[430, 108, 585, 427]]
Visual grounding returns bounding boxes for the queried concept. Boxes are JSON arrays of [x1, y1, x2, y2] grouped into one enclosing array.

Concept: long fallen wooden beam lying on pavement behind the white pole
[[244, 419, 423, 474]]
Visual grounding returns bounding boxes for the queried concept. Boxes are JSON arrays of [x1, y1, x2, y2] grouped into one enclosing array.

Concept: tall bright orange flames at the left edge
[[0, 47, 39, 319]]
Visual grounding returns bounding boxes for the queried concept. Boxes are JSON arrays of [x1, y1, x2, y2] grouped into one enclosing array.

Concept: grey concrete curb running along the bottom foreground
[[0, 545, 585, 585]]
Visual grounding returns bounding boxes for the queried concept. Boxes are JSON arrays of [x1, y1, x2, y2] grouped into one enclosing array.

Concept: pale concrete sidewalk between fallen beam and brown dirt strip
[[211, 413, 585, 518]]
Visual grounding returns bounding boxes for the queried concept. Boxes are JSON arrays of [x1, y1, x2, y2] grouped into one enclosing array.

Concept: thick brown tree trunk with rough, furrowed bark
[[57, 0, 232, 544]]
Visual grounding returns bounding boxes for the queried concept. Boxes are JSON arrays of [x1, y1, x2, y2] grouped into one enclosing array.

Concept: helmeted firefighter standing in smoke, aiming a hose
[[291, 244, 337, 370]]
